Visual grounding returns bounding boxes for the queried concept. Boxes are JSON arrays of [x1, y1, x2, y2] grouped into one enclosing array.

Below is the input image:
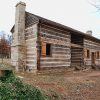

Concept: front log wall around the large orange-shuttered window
[[39, 25, 71, 68]]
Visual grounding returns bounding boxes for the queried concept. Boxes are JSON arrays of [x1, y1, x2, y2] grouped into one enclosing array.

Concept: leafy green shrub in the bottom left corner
[[0, 71, 45, 100]]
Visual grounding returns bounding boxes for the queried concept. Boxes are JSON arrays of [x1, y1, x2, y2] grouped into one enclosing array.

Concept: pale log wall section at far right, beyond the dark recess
[[84, 39, 100, 65]]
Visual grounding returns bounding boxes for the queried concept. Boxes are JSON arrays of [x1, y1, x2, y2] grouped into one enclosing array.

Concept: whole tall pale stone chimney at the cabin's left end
[[11, 2, 26, 71]]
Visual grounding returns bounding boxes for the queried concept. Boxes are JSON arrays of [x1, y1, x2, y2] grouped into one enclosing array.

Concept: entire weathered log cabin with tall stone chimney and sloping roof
[[11, 2, 100, 71]]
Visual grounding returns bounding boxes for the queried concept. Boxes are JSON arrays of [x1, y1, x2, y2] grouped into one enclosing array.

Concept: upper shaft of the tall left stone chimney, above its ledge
[[15, 2, 26, 45]]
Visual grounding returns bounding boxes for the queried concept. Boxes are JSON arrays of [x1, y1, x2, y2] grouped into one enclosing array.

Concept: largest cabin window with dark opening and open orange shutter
[[41, 42, 51, 56]]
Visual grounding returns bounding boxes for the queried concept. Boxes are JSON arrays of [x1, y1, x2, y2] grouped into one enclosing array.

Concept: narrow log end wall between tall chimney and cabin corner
[[25, 24, 38, 71]]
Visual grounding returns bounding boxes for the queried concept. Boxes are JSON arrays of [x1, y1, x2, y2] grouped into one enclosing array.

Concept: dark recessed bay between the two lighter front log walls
[[71, 34, 83, 66]]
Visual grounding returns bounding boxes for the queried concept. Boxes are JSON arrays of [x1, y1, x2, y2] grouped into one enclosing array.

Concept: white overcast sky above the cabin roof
[[0, 0, 100, 38]]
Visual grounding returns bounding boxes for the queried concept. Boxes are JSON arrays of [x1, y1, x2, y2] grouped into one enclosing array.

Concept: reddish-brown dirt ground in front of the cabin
[[17, 70, 100, 100]]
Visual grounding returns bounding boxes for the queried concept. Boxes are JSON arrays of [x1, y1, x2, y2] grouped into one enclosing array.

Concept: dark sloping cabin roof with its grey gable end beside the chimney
[[11, 12, 100, 42]]
